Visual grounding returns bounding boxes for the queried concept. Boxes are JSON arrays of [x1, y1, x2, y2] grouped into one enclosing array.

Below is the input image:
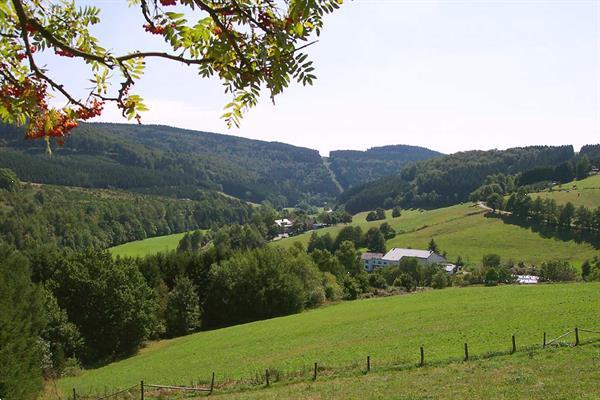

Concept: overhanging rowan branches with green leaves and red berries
[[0, 0, 342, 145]]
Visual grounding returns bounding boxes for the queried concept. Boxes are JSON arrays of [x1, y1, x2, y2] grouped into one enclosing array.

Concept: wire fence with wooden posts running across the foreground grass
[[67, 328, 600, 400]]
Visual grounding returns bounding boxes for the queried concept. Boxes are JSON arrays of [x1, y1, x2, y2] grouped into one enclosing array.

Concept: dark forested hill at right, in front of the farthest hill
[[339, 145, 575, 213]]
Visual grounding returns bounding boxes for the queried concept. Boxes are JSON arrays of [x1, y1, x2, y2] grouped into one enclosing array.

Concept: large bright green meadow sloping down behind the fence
[[57, 283, 600, 398]]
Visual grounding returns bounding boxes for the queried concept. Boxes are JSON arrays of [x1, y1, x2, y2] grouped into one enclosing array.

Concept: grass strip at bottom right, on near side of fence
[[218, 343, 600, 400]]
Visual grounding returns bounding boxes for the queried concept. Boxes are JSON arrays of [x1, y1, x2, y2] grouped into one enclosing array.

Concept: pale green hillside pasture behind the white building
[[274, 204, 600, 266]]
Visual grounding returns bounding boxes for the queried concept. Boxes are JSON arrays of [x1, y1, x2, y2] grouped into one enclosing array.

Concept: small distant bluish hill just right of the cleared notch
[[329, 145, 443, 189]]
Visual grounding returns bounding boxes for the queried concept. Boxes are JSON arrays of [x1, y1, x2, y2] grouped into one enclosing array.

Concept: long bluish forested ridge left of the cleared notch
[[0, 124, 339, 206]]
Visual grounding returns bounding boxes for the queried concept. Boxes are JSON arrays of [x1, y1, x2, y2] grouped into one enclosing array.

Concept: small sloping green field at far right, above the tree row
[[531, 175, 600, 208]]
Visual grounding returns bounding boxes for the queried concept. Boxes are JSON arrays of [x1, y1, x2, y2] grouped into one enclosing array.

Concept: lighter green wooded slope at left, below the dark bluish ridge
[[0, 170, 253, 249]]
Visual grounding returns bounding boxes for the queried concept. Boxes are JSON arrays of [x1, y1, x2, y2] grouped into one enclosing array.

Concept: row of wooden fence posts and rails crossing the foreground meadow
[[73, 327, 600, 400]]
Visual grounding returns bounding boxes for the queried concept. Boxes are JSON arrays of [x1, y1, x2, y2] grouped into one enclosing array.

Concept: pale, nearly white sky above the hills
[[43, 0, 600, 155]]
